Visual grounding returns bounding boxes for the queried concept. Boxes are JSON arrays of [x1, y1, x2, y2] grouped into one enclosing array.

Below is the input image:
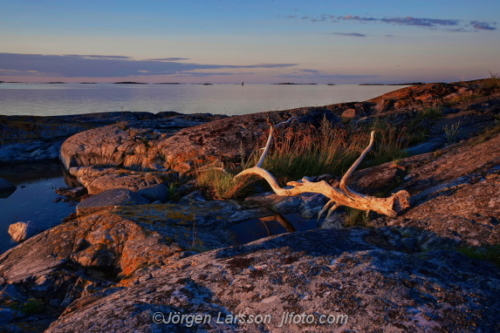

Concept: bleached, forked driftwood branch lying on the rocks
[[235, 126, 410, 218]]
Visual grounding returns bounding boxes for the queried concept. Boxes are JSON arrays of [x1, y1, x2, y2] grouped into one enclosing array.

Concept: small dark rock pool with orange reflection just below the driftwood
[[228, 214, 322, 244]]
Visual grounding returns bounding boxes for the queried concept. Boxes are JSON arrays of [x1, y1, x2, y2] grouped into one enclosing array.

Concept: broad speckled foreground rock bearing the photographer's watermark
[[47, 230, 500, 332]]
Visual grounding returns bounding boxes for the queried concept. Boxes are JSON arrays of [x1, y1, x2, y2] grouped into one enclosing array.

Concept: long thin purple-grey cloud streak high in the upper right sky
[[285, 14, 497, 32]]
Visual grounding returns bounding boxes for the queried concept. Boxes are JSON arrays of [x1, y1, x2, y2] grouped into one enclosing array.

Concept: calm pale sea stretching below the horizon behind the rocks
[[0, 83, 401, 116]]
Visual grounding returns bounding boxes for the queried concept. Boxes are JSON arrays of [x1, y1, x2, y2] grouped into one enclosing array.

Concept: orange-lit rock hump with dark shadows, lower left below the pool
[[0, 202, 269, 332]]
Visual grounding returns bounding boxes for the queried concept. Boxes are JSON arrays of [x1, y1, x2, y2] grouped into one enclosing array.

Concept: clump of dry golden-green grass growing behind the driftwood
[[197, 119, 408, 199]]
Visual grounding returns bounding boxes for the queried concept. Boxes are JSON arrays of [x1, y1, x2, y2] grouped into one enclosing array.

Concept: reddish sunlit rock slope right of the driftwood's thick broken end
[[376, 130, 500, 246]]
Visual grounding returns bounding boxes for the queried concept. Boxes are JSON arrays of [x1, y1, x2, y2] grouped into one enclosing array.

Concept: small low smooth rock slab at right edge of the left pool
[[76, 189, 149, 216]]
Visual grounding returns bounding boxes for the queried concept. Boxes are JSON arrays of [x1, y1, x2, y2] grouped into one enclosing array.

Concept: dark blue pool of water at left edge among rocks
[[0, 163, 75, 253]]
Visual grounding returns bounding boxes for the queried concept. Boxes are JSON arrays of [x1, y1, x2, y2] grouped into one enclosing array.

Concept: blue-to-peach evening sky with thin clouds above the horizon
[[0, 0, 500, 84]]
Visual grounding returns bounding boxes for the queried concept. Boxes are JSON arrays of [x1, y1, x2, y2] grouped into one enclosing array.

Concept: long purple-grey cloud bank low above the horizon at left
[[0, 53, 296, 78]]
